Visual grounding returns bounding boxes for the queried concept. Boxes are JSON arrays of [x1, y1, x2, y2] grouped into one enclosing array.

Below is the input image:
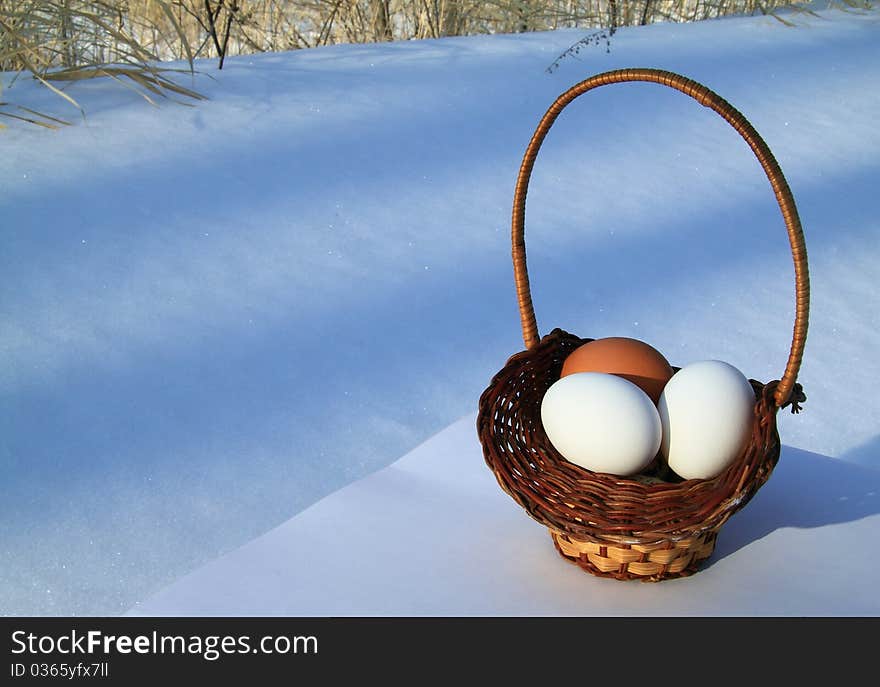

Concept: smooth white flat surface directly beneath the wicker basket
[[126, 416, 880, 617]]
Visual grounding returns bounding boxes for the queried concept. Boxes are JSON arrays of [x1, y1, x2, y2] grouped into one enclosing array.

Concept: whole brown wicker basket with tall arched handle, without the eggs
[[477, 69, 809, 581]]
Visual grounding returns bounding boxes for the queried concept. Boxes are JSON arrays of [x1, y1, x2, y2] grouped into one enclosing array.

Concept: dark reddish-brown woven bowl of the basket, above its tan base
[[477, 328, 779, 545]]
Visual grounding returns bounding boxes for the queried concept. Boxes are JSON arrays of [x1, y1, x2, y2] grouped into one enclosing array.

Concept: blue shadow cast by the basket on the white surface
[[705, 445, 880, 568]]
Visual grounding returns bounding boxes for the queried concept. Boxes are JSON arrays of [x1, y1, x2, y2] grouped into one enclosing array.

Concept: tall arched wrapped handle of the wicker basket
[[511, 69, 810, 407]]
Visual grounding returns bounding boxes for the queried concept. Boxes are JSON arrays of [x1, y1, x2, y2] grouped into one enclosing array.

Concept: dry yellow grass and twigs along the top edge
[[0, 0, 876, 128]]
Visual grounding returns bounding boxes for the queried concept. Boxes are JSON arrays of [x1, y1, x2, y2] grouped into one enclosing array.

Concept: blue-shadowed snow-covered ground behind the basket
[[0, 10, 880, 615]]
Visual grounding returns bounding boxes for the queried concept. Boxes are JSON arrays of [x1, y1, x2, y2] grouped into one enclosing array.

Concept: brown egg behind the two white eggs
[[561, 336, 672, 404]]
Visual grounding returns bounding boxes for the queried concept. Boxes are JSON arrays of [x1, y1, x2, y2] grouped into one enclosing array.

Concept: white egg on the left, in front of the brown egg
[[541, 372, 661, 476]]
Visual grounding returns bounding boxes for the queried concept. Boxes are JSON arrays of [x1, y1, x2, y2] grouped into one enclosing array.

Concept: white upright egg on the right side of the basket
[[657, 360, 755, 479]]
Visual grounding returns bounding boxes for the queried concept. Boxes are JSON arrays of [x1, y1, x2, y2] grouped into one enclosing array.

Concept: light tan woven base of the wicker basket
[[550, 530, 718, 582]]
